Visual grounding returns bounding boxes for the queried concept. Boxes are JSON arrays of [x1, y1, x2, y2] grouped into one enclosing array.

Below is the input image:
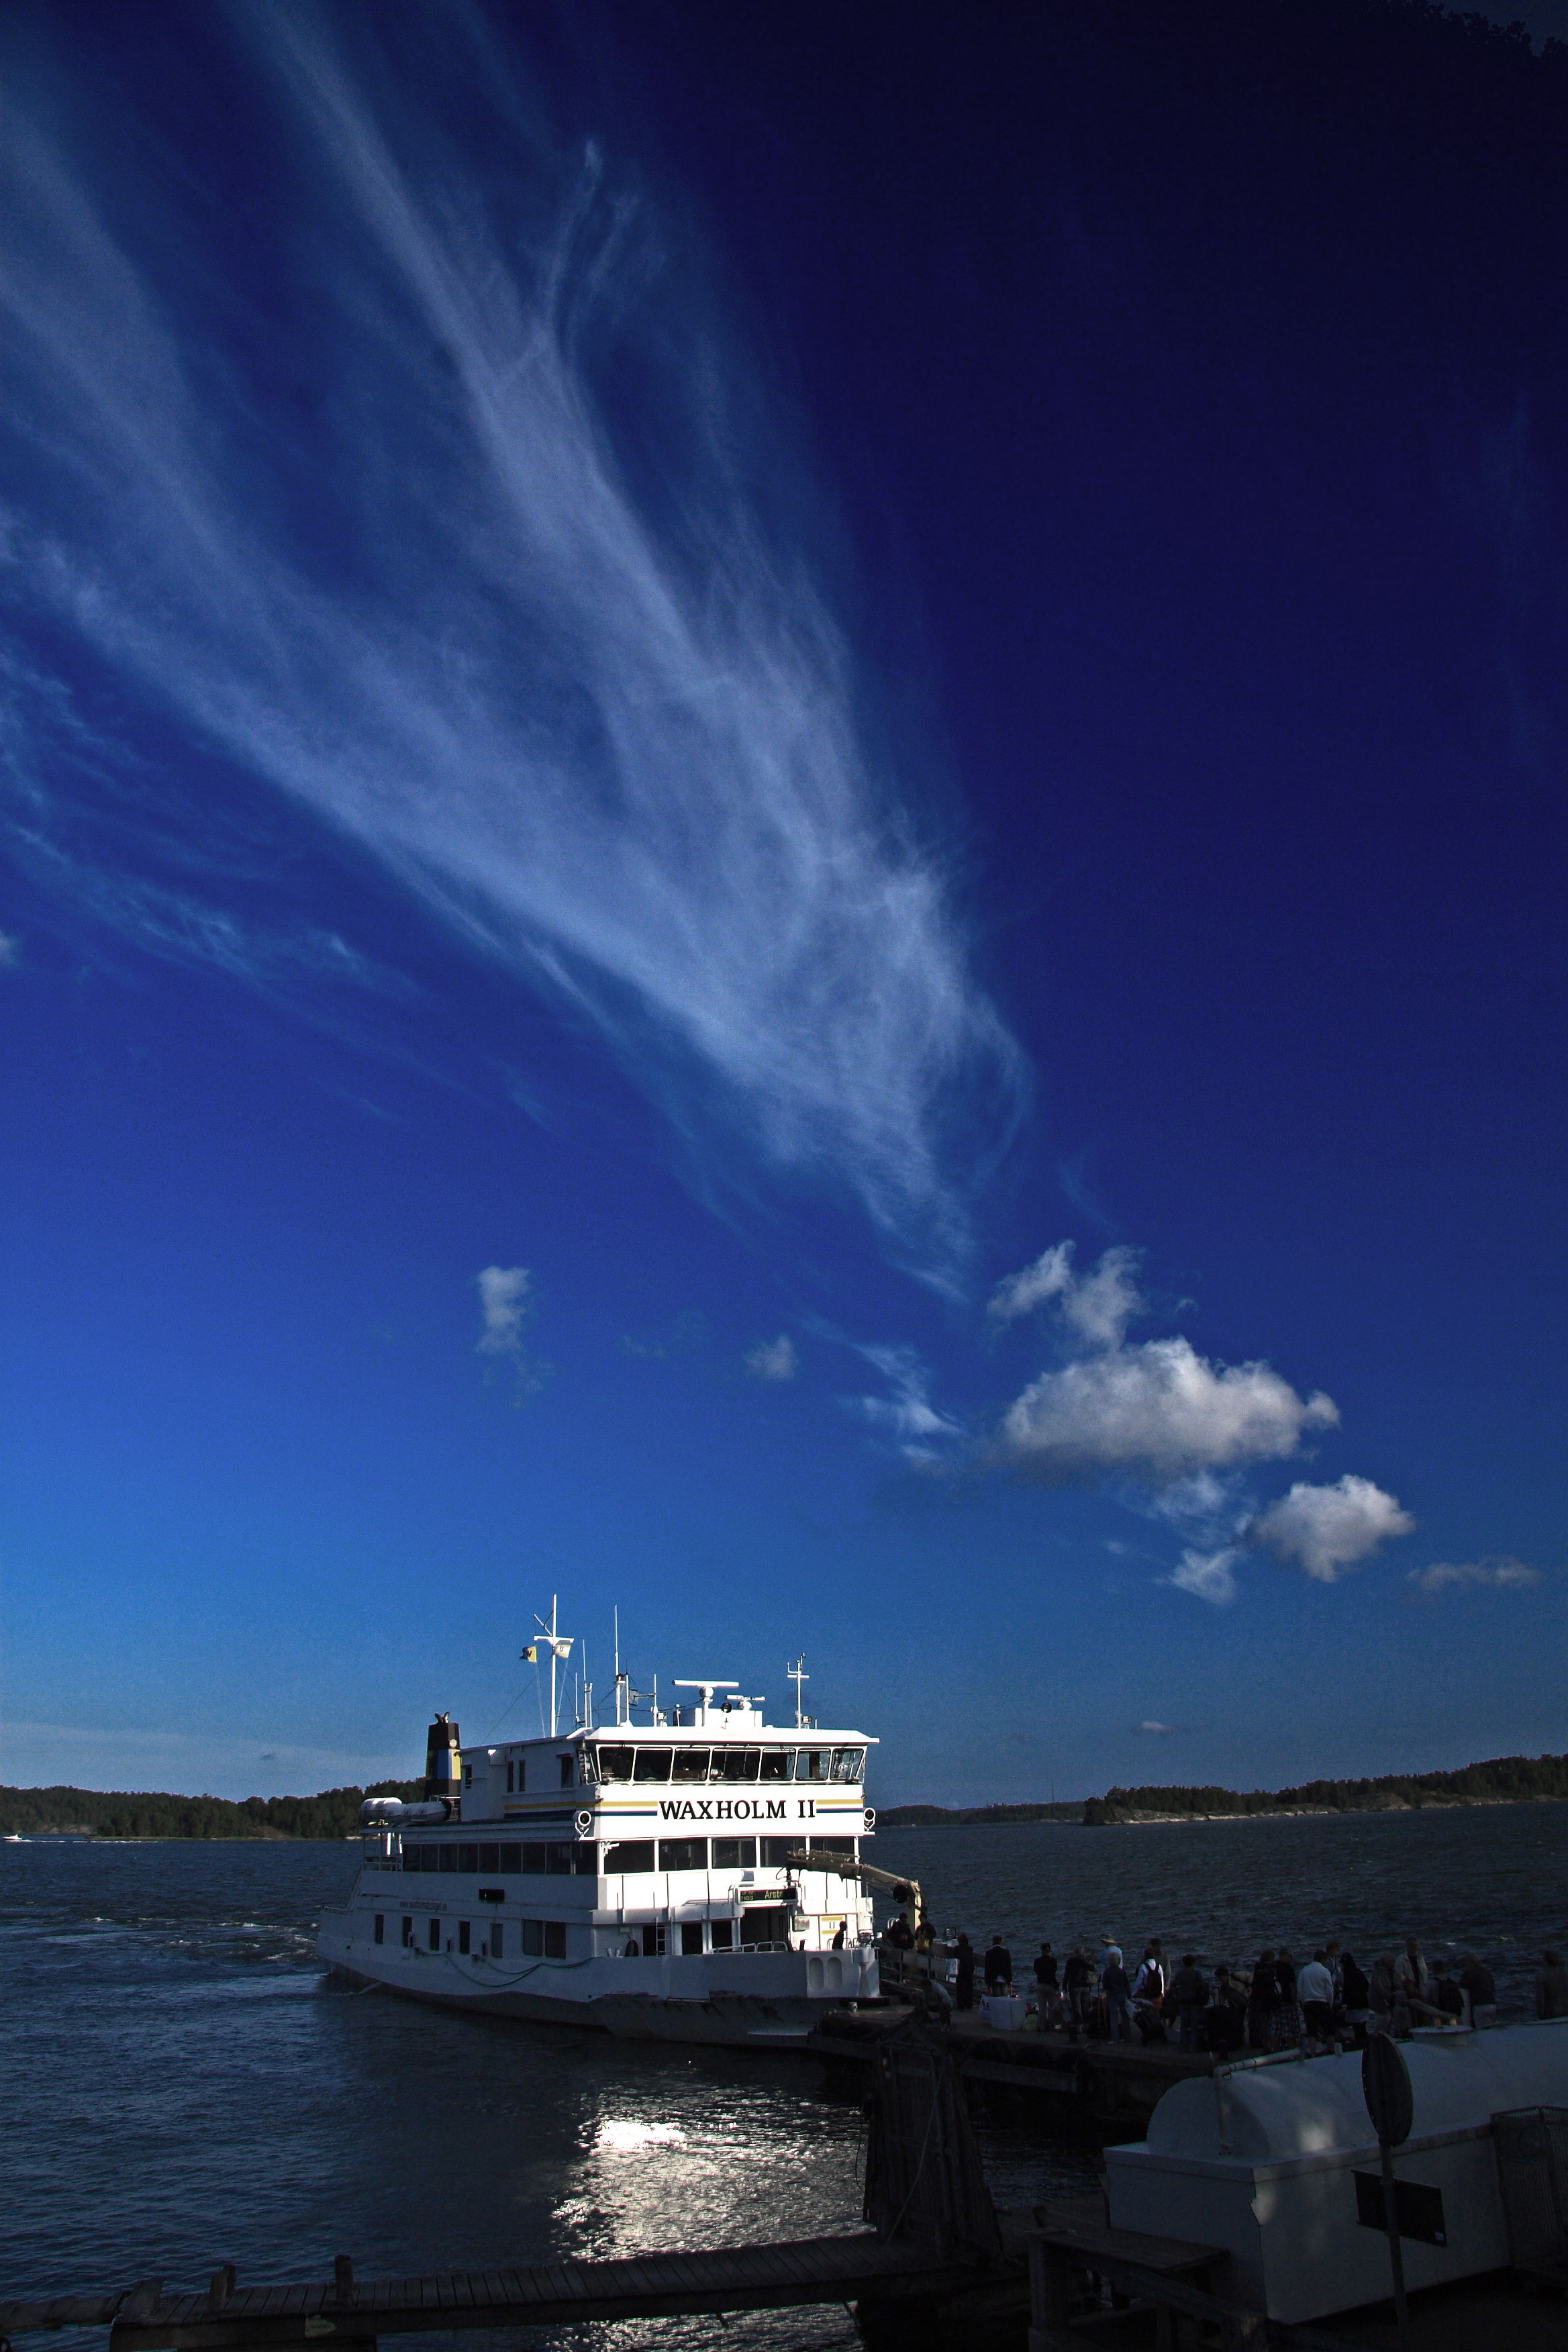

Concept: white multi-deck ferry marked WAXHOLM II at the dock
[[317, 1606, 883, 2046]]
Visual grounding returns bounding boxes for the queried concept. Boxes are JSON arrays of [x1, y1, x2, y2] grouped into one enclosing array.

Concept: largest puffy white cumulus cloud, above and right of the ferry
[[997, 1336, 1340, 1487]]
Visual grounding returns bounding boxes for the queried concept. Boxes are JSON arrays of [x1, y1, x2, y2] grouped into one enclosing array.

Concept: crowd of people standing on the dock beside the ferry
[[889, 1912, 1568, 2058]]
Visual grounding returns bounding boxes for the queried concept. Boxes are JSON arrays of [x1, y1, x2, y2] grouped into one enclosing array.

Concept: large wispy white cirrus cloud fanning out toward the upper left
[[0, 7, 1025, 1277]]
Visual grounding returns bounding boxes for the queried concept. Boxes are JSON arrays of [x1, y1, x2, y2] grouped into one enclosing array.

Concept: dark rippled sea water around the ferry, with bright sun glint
[[0, 1806, 1568, 2352]]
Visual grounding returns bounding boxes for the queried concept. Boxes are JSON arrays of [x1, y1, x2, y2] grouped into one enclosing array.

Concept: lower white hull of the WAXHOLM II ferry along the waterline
[[317, 1910, 877, 2049]]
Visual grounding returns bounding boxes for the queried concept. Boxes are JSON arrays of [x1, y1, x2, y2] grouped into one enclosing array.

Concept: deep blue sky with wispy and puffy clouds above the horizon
[[0, 0, 1568, 1802]]
